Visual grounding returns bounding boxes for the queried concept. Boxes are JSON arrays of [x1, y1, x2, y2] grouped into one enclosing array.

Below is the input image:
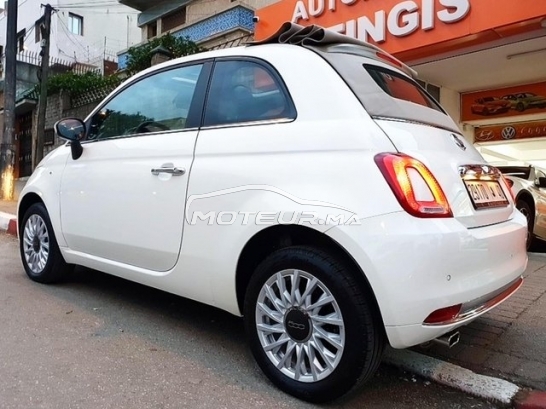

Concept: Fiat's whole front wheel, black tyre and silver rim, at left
[[19, 203, 72, 284]]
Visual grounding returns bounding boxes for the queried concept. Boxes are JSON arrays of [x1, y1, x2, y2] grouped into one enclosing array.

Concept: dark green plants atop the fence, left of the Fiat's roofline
[[47, 71, 121, 97]]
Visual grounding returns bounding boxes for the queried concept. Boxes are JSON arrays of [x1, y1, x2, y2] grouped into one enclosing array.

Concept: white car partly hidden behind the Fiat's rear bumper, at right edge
[[498, 166, 546, 249]]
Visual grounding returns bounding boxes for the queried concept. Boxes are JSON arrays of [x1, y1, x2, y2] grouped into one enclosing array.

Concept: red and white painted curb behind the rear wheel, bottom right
[[383, 348, 546, 409]]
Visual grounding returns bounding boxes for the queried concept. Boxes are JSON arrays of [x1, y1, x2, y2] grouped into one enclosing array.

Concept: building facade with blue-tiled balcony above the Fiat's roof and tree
[[115, 0, 275, 69]]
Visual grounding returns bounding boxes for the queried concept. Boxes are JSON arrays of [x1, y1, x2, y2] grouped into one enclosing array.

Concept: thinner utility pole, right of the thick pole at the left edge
[[34, 0, 53, 170]]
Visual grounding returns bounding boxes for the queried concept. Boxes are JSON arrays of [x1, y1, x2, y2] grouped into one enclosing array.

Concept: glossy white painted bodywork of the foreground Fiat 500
[[21, 45, 527, 348]]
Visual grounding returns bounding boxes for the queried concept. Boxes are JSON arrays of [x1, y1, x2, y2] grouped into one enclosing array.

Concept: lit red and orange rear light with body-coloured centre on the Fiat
[[375, 153, 453, 217]]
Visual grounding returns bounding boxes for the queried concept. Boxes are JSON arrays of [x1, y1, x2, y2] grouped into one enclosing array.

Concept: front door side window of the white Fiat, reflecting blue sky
[[87, 65, 203, 140]]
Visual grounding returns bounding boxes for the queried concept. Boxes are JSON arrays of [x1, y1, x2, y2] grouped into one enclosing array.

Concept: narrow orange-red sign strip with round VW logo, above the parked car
[[474, 121, 546, 143]]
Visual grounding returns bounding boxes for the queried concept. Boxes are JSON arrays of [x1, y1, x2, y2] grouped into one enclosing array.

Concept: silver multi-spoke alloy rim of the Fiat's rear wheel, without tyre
[[256, 269, 345, 383]]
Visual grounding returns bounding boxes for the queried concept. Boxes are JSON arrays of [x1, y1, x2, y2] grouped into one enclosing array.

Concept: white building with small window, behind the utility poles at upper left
[[0, 0, 141, 66]]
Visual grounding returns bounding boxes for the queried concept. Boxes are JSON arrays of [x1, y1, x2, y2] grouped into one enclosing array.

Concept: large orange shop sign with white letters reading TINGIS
[[255, 0, 546, 61]]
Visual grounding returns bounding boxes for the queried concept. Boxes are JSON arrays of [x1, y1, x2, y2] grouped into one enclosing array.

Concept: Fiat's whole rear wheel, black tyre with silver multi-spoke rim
[[244, 246, 385, 403]]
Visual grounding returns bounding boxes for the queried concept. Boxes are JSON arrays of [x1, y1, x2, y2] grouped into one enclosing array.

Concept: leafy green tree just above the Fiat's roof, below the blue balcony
[[127, 34, 204, 75]]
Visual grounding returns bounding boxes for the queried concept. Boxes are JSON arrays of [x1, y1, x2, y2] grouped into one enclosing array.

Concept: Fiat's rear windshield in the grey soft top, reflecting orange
[[364, 64, 443, 112]]
